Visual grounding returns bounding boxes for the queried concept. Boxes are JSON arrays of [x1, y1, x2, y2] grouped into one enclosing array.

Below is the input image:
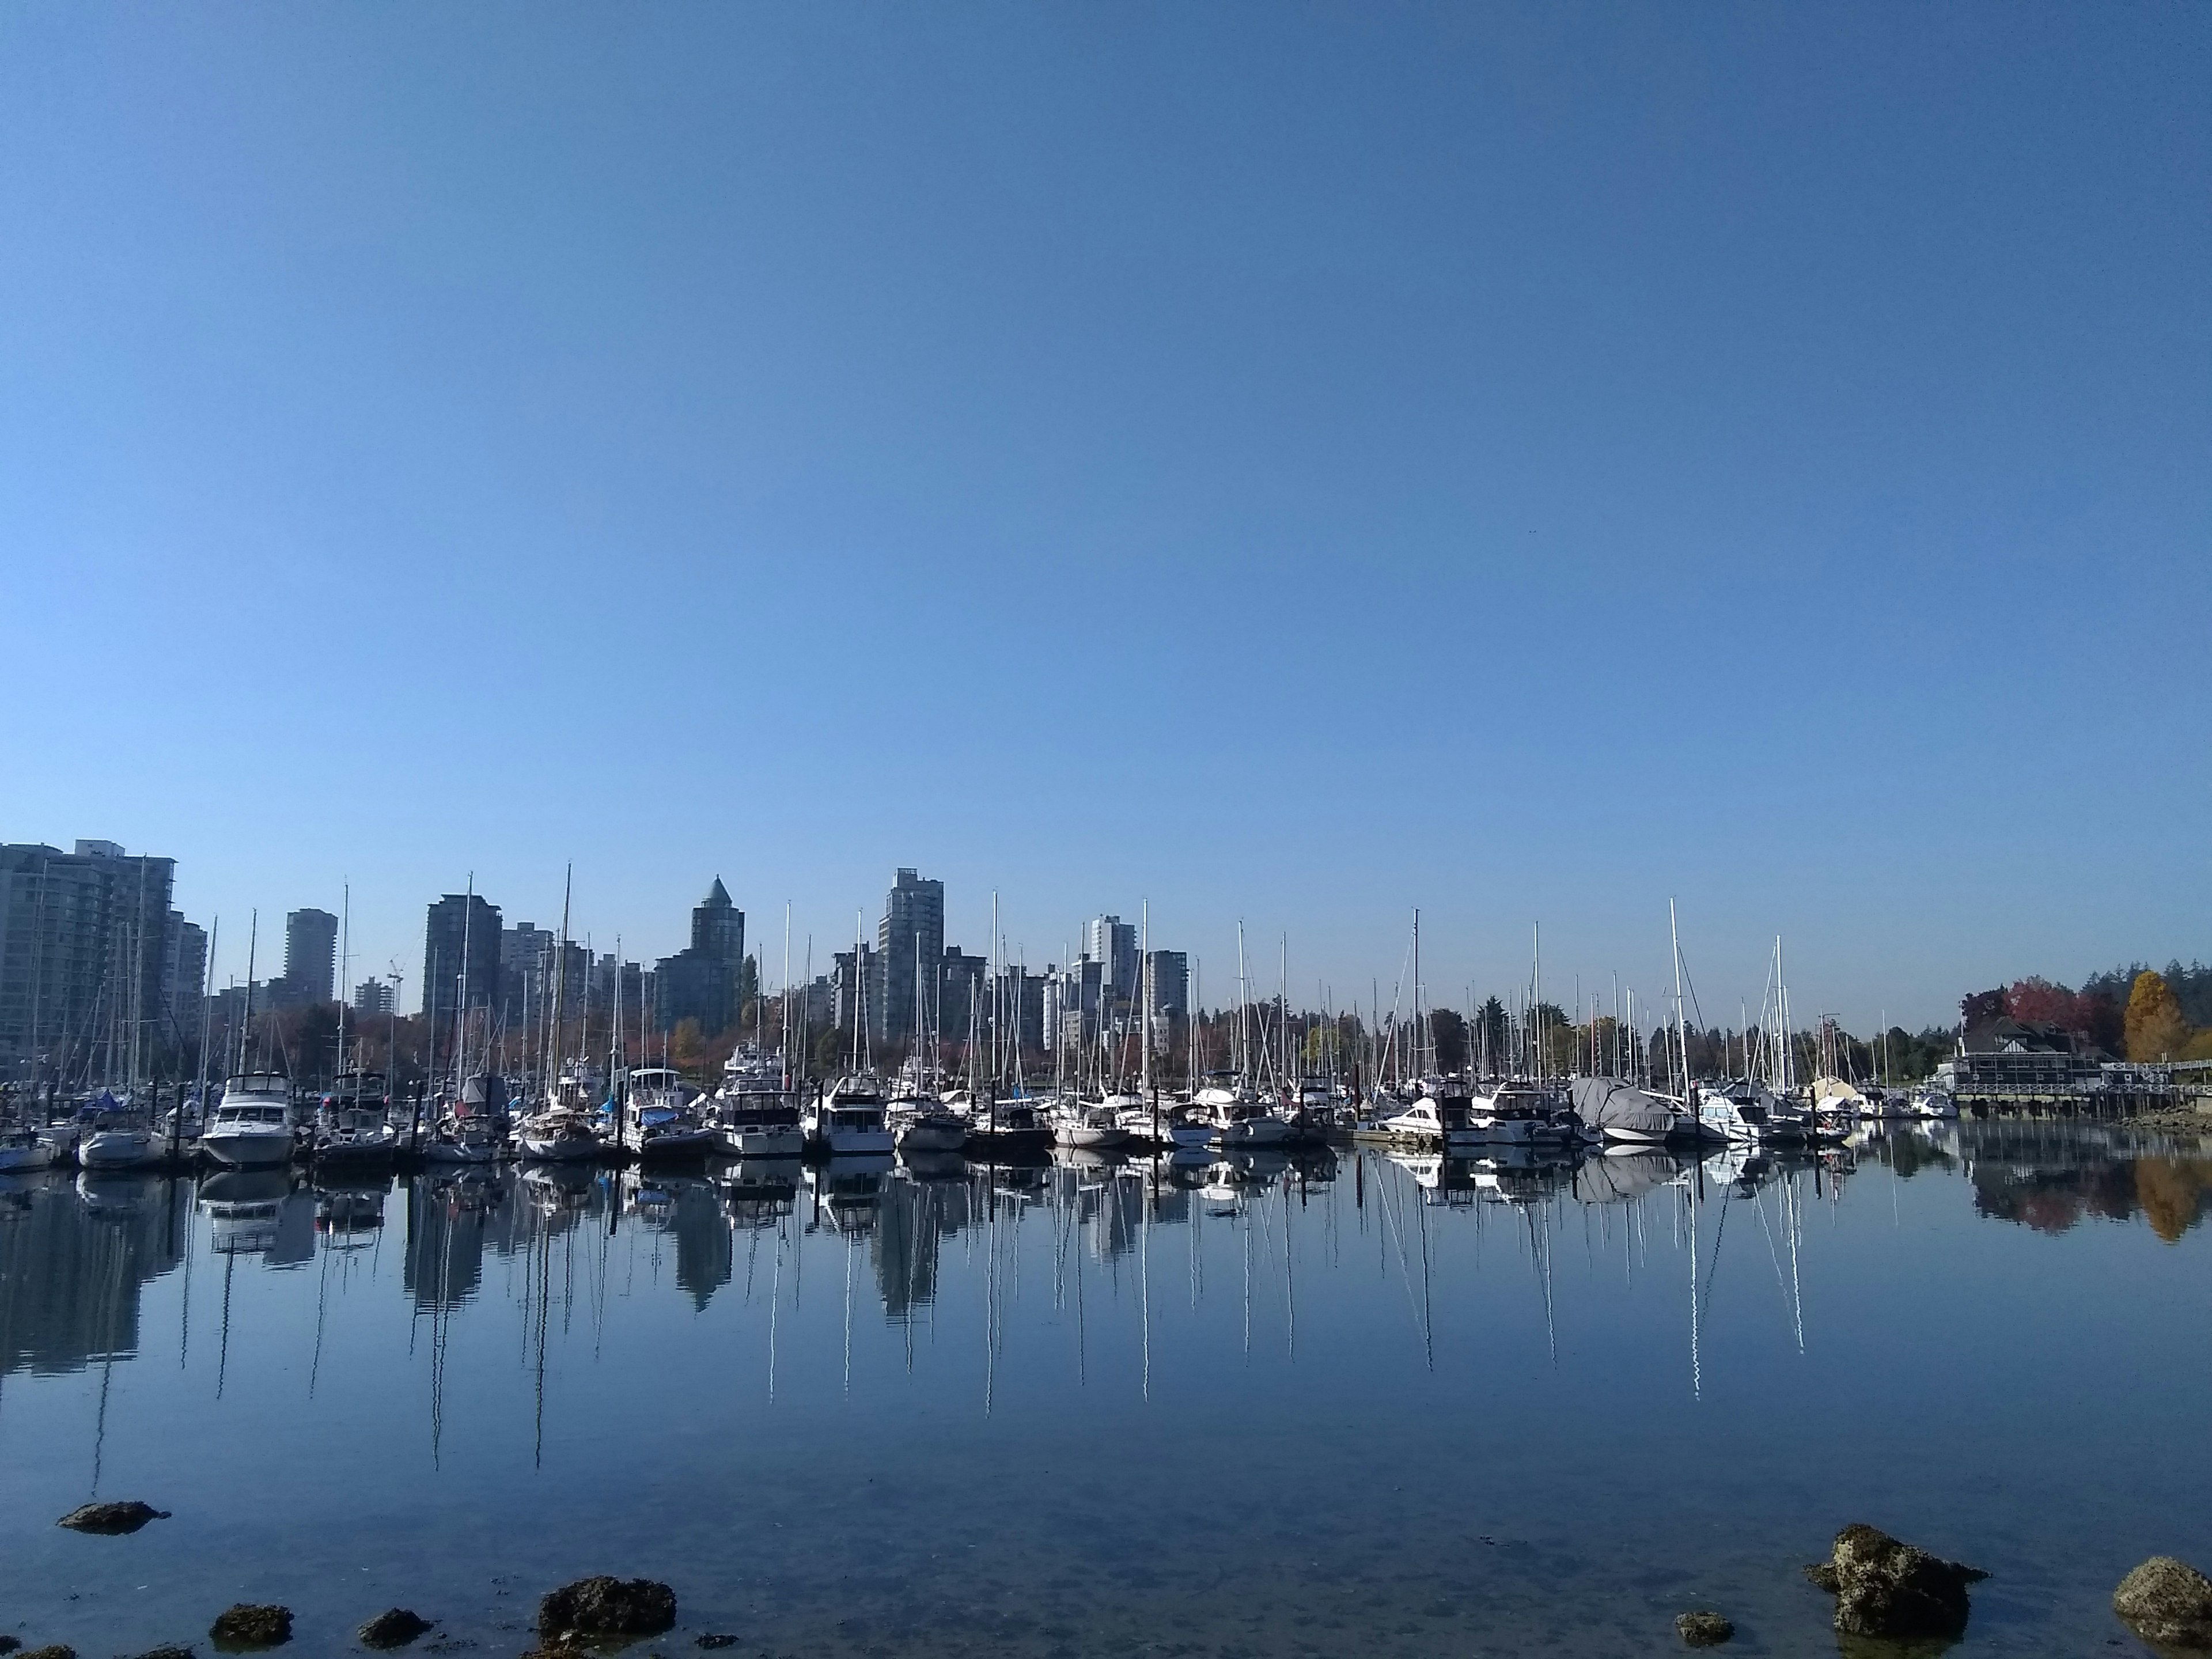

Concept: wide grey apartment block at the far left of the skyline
[[0, 840, 184, 1082]]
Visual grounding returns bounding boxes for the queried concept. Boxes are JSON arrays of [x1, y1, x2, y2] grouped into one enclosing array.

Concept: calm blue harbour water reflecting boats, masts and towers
[[0, 1124, 2212, 1659]]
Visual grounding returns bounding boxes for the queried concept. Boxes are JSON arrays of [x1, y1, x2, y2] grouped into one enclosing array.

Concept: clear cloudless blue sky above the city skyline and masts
[[0, 2, 2212, 1027]]
